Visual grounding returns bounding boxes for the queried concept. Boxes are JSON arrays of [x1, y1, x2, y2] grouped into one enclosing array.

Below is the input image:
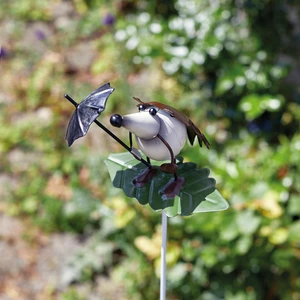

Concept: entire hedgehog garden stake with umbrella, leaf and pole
[[65, 83, 228, 300]]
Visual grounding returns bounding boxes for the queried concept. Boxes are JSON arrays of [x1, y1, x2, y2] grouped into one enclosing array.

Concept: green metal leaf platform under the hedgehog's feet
[[105, 153, 228, 217]]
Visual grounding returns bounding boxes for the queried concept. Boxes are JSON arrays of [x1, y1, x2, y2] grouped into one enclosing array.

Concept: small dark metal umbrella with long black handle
[[65, 83, 151, 167]]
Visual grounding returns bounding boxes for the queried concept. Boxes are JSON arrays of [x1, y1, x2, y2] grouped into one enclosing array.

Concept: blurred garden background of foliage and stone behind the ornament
[[0, 0, 300, 300]]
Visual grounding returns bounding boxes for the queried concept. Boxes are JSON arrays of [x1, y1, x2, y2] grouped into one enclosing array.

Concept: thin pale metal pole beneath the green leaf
[[160, 211, 168, 300]]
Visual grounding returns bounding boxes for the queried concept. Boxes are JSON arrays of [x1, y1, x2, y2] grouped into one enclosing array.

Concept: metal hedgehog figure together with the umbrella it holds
[[65, 83, 210, 198]]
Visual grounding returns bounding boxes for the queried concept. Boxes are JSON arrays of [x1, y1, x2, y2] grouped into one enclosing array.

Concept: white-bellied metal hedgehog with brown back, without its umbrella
[[110, 97, 210, 198]]
